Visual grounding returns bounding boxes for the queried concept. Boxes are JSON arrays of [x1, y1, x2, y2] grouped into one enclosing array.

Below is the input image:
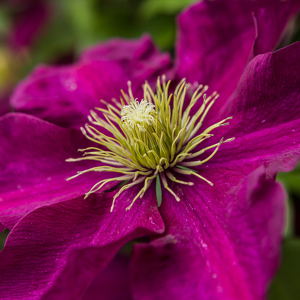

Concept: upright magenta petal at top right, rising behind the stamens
[[176, 0, 299, 121]]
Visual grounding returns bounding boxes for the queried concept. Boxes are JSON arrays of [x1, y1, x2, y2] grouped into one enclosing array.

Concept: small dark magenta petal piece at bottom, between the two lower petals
[[82, 255, 132, 300]]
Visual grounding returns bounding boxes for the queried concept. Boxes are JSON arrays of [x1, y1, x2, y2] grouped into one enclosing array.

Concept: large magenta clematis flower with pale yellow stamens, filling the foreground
[[0, 1, 300, 300]]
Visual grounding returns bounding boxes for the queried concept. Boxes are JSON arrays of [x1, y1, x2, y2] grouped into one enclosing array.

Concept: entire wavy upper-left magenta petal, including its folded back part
[[11, 36, 171, 128]]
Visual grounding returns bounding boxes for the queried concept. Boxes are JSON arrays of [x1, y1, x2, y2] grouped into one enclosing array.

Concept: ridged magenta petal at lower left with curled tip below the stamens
[[0, 190, 164, 300]]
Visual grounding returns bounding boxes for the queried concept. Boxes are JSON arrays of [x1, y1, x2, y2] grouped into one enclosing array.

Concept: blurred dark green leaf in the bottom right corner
[[268, 239, 300, 300]]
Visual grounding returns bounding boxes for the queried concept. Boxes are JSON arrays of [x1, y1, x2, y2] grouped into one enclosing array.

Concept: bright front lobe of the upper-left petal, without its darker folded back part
[[11, 61, 129, 128]]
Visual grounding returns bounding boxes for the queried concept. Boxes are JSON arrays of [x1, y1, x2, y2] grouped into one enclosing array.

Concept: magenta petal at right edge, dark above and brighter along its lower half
[[210, 43, 300, 175]]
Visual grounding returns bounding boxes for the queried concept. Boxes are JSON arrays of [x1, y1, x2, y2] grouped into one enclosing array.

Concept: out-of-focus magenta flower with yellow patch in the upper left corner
[[0, 0, 50, 116]]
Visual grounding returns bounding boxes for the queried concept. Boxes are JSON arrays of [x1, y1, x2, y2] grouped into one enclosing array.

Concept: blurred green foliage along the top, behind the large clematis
[[29, 0, 192, 68]]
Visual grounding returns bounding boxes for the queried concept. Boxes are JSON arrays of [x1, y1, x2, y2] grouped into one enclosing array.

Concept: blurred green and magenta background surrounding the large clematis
[[0, 0, 300, 300]]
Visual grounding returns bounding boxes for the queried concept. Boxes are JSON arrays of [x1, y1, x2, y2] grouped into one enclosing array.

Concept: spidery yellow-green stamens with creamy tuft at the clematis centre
[[67, 76, 234, 211]]
